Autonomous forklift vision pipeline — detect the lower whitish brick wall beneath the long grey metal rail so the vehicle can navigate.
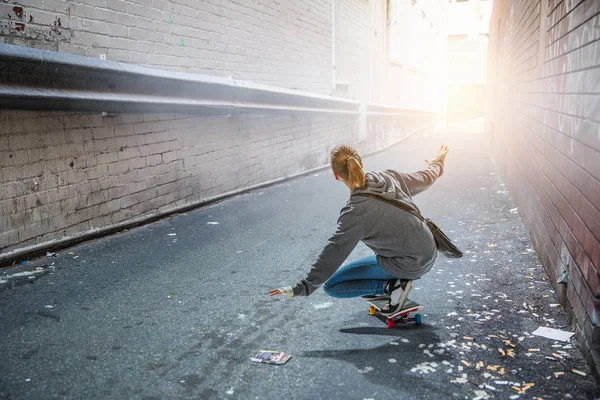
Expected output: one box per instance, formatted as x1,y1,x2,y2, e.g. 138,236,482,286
0,111,426,252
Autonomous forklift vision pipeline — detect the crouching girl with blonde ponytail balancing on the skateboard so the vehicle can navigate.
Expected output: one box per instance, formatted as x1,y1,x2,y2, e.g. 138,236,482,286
269,145,448,315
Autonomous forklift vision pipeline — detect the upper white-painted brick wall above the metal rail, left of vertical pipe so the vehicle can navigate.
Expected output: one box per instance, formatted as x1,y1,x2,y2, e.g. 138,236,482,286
0,0,332,93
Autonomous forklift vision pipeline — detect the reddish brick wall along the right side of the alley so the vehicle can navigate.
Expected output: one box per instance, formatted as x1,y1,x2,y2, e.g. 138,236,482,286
487,0,600,356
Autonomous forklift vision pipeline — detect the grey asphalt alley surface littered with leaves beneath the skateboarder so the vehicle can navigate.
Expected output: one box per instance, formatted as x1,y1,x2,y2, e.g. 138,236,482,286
0,120,596,400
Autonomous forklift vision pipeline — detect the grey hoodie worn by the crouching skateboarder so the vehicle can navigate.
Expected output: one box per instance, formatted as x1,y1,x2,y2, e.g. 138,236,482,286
293,162,444,296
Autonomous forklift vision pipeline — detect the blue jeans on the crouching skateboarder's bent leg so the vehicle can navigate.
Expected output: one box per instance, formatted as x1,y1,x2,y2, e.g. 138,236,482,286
323,255,398,298
